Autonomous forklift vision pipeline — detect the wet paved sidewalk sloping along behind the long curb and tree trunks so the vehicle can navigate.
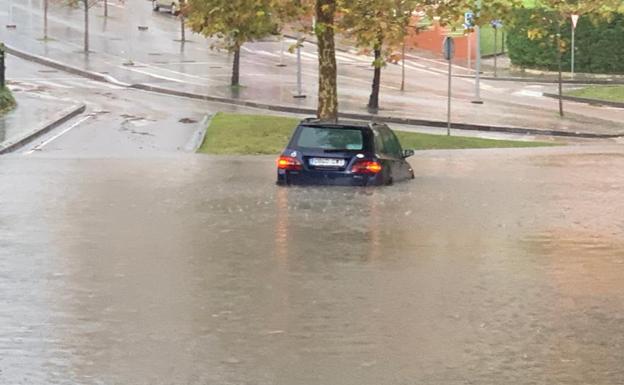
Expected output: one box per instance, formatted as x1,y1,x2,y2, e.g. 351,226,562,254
0,3,624,136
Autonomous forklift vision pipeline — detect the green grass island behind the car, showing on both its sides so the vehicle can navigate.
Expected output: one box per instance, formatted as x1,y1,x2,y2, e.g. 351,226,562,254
198,112,554,155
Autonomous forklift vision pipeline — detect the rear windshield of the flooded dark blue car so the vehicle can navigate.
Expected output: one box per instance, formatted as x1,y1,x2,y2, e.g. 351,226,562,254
297,126,364,151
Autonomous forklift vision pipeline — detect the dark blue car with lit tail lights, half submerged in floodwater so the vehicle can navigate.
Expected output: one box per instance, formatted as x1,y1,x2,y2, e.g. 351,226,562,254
277,119,414,186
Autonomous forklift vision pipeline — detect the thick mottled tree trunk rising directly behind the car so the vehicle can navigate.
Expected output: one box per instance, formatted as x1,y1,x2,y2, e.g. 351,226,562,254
315,0,338,121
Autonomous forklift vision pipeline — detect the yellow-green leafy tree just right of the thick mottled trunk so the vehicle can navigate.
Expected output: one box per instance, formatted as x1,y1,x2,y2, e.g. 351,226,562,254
341,0,419,111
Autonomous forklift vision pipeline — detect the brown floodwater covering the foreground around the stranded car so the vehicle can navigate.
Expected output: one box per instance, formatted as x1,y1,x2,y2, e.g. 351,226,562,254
0,147,624,385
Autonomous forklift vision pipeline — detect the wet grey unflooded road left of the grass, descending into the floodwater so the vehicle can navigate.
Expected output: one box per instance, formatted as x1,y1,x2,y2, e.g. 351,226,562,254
7,57,290,157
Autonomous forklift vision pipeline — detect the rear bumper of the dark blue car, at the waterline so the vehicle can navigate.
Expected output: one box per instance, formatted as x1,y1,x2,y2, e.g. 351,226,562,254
277,170,384,186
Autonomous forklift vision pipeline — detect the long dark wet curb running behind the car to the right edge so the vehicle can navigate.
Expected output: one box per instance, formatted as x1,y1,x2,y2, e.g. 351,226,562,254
130,84,624,139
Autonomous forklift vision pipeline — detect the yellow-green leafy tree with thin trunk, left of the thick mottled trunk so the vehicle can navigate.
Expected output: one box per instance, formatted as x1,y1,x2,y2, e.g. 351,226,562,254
187,0,277,86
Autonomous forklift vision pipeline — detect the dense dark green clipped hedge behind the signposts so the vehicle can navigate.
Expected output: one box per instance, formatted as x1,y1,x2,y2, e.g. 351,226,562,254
507,9,624,74
